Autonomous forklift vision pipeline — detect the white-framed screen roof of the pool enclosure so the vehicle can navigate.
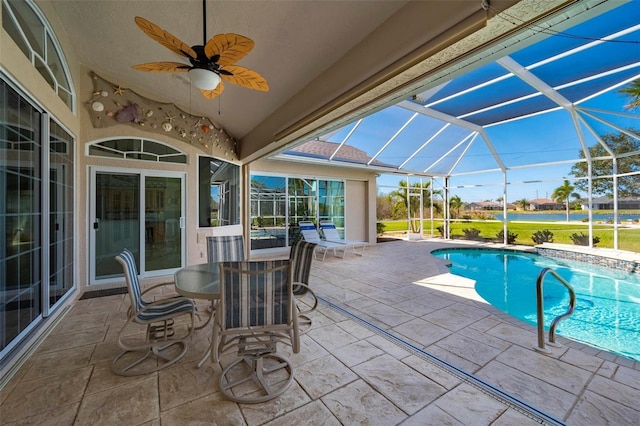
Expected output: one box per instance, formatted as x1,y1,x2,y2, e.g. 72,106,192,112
275,1,640,180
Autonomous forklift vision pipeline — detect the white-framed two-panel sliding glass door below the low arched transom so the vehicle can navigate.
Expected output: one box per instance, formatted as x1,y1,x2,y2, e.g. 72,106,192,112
90,169,184,284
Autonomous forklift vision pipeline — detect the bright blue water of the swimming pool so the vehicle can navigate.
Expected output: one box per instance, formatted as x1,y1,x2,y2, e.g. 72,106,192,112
432,249,640,361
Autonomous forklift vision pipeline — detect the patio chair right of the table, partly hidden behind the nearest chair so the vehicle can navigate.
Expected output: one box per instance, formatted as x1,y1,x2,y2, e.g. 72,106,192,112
289,240,318,334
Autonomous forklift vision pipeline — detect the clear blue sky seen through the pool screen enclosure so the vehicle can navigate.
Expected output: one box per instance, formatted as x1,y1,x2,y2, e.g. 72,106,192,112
327,1,640,202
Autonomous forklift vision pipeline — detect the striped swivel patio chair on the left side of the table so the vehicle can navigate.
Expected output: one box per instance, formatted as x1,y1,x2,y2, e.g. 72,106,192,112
111,249,196,376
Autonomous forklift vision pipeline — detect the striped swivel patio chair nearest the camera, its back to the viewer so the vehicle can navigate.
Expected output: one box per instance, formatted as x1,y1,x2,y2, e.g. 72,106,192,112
211,260,300,403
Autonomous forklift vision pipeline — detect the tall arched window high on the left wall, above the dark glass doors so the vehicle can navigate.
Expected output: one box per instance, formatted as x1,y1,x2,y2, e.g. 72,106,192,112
2,0,75,112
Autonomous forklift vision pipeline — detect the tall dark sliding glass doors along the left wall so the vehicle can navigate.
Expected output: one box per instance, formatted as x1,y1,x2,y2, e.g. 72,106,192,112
0,74,75,360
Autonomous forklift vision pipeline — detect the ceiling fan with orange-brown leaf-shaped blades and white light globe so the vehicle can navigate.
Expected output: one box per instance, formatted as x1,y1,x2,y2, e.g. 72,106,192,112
133,0,269,99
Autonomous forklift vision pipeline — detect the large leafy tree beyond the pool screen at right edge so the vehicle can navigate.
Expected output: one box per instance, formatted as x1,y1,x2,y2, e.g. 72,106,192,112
571,129,640,197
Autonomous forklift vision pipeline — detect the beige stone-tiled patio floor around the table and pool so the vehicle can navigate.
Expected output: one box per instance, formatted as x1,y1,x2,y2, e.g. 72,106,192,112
0,241,640,426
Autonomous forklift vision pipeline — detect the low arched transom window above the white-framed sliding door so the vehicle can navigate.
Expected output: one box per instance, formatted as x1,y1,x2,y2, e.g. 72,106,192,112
87,139,187,164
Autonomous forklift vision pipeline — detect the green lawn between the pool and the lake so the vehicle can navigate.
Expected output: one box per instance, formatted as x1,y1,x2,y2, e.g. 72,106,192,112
382,220,640,252
